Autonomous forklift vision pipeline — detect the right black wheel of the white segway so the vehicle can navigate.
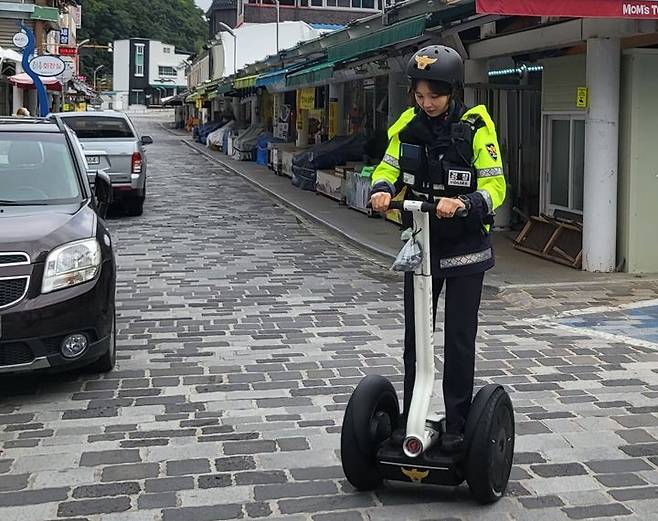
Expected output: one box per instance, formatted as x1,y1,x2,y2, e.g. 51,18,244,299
466,387,514,504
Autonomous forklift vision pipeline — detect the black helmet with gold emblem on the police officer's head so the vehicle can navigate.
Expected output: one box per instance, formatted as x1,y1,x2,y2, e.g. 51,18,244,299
407,45,464,89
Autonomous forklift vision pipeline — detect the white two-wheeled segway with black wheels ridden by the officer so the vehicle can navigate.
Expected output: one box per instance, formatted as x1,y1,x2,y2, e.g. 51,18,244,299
340,197,514,504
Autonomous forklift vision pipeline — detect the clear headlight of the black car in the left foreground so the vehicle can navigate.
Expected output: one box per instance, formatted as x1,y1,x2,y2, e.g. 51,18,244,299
41,239,101,293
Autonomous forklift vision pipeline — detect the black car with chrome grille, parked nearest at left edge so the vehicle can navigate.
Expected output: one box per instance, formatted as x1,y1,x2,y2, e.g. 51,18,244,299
0,118,116,374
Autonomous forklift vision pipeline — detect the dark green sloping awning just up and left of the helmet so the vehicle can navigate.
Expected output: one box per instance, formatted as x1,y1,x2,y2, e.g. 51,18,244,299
327,16,427,62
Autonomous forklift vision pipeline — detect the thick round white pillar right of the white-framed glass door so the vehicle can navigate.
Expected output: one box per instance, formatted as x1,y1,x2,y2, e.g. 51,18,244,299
583,38,621,272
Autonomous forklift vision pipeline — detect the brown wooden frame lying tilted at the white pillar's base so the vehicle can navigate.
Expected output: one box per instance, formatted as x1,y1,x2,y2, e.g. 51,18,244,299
514,214,583,269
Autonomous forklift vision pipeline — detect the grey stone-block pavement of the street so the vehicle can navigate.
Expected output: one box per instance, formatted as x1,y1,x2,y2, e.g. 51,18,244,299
0,114,658,521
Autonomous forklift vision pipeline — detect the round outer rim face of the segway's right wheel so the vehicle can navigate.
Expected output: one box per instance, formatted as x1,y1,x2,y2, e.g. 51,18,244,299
490,405,514,495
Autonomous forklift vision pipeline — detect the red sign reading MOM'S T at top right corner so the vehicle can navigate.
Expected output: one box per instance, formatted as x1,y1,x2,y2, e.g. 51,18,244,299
477,0,658,19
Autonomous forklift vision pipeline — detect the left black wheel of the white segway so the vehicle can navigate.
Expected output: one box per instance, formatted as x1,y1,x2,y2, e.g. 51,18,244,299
340,375,400,490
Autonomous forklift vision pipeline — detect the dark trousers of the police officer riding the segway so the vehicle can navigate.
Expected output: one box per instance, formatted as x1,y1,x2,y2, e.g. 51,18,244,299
404,273,484,433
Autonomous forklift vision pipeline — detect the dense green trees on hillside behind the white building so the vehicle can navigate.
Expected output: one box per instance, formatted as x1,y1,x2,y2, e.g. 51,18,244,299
78,0,208,83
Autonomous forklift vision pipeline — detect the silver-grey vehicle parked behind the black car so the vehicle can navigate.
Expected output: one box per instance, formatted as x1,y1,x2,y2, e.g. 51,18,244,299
53,111,153,216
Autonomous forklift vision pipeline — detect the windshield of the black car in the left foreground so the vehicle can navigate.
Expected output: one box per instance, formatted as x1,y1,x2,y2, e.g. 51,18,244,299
0,132,81,205
